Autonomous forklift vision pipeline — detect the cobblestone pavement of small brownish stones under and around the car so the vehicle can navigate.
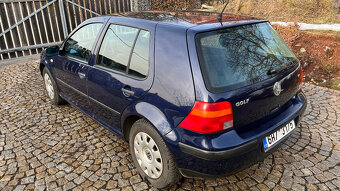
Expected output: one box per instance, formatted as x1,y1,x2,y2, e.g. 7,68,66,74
0,63,340,191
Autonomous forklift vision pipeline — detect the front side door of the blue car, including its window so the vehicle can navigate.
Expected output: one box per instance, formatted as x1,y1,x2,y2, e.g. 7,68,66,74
54,23,103,110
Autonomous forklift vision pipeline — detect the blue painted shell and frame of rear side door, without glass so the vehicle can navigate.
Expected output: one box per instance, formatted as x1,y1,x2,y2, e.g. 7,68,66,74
87,17,156,130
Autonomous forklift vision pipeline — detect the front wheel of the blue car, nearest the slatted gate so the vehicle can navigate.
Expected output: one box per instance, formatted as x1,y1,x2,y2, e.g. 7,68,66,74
42,67,65,105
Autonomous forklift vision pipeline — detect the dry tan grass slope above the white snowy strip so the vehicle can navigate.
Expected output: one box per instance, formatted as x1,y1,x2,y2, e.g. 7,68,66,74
215,0,340,24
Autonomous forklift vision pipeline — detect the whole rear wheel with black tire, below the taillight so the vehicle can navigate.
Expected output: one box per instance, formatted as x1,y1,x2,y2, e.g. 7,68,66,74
129,119,182,188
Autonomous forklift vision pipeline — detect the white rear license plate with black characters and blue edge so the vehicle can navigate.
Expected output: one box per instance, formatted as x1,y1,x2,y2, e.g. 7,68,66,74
263,120,295,151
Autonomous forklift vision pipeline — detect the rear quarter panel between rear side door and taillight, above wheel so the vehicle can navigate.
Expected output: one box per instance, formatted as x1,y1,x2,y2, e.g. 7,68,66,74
122,24,195,135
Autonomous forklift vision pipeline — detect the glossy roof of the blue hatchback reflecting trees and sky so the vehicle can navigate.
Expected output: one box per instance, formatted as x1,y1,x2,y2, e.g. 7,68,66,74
102,11,266,29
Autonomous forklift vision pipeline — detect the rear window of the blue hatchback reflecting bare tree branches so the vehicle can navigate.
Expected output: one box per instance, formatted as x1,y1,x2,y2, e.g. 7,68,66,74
196,23,298,92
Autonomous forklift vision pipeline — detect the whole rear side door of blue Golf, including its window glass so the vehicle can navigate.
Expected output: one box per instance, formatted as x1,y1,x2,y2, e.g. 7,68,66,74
88,23,153,128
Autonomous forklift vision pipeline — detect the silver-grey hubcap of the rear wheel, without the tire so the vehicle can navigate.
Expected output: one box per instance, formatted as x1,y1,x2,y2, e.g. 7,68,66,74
134,132,163,178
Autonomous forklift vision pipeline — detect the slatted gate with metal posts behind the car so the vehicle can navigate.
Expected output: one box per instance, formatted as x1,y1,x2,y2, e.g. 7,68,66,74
0,0,131,61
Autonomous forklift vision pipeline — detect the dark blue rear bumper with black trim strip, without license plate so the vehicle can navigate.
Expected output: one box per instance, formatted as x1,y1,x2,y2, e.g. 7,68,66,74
165,93,307,177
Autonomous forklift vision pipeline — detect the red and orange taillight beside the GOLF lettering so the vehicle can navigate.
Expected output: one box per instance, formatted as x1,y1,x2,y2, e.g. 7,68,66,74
179,101,233,133
